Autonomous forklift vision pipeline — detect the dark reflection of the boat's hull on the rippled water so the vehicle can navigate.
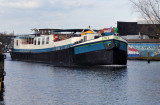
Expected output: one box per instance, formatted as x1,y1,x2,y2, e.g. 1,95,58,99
59,66,127,80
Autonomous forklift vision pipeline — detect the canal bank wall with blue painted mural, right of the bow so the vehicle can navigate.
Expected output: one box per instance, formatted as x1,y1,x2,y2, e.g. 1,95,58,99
127,39,160,61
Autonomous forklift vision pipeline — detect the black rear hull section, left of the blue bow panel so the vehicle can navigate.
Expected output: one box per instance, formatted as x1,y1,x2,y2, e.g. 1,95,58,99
10,48,74,66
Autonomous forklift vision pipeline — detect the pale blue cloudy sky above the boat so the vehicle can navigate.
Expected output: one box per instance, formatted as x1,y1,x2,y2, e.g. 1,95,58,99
0,0,137,34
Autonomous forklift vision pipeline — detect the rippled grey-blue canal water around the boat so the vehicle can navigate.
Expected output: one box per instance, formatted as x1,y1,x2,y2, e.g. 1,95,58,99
0,54,160,105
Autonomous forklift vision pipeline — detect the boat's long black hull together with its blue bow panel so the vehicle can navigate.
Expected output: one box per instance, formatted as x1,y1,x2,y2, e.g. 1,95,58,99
11,40,127,66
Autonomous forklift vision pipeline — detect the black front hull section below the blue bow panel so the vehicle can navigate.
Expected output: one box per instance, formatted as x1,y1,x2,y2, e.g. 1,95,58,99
75,48,127,65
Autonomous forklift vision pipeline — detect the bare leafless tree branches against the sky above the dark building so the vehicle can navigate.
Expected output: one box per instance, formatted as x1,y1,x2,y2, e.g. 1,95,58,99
130,0,160,24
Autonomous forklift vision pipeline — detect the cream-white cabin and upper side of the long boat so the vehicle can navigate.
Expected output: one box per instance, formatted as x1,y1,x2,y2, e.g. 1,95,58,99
14,33,125,49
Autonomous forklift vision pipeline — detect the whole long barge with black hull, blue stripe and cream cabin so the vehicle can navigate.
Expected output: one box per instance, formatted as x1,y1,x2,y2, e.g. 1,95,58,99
10,29,127,66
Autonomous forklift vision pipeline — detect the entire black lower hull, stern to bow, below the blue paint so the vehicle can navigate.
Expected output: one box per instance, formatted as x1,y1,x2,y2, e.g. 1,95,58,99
11,47,127,66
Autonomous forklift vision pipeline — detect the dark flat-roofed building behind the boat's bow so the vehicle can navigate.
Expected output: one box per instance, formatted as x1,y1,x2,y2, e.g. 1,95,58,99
117,21,160,39
